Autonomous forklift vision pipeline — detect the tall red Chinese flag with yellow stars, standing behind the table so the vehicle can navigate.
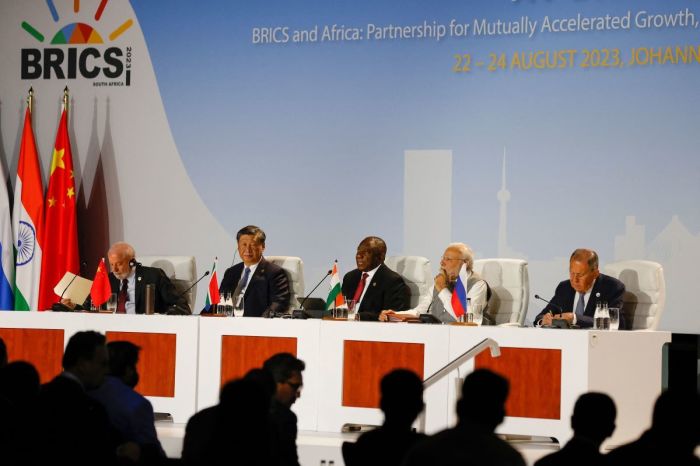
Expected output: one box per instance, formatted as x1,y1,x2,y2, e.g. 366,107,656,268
39,106,80,310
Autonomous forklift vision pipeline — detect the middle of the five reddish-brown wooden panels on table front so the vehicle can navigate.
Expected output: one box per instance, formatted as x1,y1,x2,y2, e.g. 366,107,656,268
220,335,297,386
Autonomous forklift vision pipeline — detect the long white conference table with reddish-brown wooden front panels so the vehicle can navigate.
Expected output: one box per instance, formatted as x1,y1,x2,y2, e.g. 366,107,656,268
0,312,671,445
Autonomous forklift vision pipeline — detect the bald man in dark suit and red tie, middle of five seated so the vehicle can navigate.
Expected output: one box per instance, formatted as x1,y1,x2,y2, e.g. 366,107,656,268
342,236,411,320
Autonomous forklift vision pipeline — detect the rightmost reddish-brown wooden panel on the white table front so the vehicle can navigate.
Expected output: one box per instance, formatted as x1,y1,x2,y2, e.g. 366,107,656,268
474,347,561,419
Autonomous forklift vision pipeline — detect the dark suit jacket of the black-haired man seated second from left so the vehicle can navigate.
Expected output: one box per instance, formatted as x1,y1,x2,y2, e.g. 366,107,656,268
219,257,291,317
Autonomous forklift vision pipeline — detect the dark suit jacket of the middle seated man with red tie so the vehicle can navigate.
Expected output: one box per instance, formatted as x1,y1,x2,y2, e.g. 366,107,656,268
342,264,411,320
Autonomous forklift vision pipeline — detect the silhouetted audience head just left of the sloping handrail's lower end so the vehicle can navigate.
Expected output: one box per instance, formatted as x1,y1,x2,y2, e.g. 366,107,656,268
379,369,424,426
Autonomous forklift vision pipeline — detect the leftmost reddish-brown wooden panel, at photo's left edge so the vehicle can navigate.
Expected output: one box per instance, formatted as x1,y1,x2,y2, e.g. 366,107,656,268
0,328,65,383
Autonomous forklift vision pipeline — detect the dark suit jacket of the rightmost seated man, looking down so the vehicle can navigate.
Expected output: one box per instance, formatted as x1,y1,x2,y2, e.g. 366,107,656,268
535,273,627,329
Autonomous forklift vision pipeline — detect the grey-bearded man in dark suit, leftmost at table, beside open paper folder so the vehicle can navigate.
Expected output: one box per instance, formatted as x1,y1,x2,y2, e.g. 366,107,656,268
107,242,191,314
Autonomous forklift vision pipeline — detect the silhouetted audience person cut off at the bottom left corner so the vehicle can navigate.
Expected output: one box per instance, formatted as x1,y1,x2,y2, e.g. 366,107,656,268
0,361,41,465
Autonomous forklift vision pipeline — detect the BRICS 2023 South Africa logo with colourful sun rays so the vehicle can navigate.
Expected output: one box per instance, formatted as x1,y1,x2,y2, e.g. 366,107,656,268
21,0,134,86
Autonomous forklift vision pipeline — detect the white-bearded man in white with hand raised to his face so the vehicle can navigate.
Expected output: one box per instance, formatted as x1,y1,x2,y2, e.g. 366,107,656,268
379,243,491,325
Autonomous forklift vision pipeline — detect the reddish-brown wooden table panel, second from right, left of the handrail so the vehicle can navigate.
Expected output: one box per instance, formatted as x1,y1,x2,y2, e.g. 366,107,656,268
343,340,425,408
